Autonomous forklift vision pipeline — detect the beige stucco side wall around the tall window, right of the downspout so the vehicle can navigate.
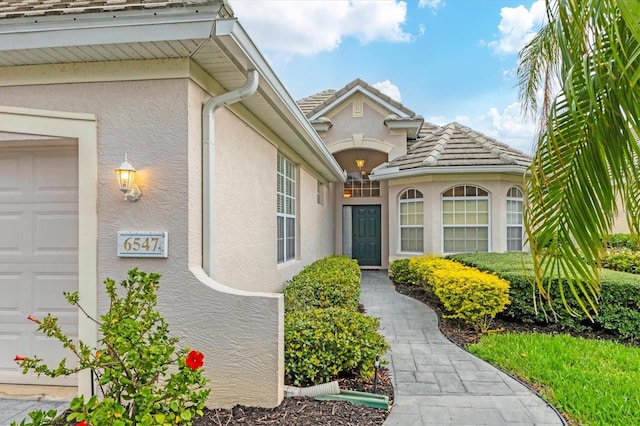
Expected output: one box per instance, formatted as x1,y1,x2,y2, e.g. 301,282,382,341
214,109,340,292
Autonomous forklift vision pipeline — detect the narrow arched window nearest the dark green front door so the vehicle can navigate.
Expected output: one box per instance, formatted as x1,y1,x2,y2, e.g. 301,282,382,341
399,189,424,253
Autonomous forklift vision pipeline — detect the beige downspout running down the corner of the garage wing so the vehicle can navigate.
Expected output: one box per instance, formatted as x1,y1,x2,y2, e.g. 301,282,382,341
202,70,259,279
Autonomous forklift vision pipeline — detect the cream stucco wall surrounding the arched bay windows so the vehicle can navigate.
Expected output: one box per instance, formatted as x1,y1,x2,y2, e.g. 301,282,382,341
389,173,523,262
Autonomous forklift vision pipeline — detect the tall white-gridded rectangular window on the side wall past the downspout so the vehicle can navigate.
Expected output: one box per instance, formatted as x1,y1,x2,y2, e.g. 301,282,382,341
277,153,296,263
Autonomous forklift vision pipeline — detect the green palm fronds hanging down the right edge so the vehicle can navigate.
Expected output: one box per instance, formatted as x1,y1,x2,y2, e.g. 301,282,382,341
518,0,640,314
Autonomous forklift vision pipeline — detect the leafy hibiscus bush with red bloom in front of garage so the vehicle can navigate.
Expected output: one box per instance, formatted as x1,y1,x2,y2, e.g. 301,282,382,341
15,269,209,426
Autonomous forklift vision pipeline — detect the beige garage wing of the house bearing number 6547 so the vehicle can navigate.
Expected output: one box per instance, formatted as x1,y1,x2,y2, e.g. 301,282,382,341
0,0,346,406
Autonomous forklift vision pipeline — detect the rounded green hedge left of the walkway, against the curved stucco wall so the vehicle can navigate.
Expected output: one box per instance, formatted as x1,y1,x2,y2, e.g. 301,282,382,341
284,255,389,385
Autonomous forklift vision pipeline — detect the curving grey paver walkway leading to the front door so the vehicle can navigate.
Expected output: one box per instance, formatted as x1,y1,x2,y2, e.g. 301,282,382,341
360,271,565,426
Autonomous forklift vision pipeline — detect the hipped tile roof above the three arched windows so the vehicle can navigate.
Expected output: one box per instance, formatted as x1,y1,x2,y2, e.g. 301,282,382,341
387,122,531,171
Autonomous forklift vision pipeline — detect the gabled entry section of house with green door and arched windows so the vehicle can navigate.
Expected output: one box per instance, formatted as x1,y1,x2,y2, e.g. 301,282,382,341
298,79,531,269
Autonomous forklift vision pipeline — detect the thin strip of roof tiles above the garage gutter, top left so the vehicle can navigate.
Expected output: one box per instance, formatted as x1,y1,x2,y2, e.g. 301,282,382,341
0,0,233,19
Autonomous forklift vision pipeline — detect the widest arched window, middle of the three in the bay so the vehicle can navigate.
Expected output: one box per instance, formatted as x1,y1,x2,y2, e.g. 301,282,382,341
442,185,489,253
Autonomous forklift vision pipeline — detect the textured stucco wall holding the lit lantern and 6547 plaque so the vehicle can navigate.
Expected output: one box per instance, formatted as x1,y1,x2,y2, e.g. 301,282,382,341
0,79,283,406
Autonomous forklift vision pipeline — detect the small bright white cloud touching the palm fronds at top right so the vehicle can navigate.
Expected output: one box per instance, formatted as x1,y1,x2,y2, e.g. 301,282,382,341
486,0,546,54
